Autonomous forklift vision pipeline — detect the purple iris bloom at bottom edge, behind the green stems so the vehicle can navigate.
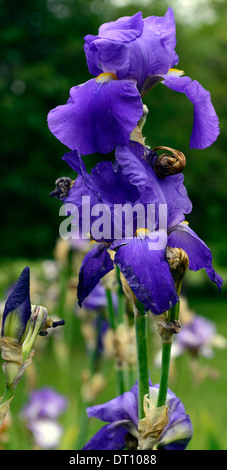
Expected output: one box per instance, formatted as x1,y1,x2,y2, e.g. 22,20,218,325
84,383,193,450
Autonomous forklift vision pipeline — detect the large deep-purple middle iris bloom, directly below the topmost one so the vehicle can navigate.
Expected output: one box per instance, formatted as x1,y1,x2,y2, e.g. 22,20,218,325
63,143,222,314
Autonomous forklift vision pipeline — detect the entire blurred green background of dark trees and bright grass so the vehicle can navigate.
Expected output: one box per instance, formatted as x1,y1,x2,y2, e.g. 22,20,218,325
0,0,227,449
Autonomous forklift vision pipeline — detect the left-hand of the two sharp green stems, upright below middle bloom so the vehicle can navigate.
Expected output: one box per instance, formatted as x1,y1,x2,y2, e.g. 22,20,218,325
135,312,149,421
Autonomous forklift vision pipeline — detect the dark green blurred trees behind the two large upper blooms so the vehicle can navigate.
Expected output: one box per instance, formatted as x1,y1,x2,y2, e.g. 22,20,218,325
0,0,227,266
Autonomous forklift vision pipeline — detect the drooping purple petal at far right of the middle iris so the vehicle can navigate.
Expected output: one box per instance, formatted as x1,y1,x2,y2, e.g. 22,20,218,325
167,223,223,289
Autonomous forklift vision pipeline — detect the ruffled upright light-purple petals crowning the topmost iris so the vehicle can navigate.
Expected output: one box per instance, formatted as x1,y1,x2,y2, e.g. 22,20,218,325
84,8,178,90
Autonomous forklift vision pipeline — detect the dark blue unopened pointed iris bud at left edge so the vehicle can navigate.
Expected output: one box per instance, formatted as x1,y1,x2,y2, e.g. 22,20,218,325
1,266,31,342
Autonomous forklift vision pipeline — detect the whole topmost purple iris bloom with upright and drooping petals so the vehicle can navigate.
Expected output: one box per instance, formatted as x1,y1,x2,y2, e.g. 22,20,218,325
48,8,219,155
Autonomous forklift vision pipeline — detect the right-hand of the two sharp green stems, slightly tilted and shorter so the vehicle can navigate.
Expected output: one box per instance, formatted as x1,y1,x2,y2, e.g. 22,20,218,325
157,341,172,407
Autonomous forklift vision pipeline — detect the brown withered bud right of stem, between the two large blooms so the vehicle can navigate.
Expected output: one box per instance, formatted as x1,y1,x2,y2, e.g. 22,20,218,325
153,146,186,178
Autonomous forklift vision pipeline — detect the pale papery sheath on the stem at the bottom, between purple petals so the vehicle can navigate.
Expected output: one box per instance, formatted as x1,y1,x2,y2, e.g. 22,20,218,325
138,395,169,450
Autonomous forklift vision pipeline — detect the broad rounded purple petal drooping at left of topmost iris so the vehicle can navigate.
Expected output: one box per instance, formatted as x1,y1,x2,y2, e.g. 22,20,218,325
48,73,143,155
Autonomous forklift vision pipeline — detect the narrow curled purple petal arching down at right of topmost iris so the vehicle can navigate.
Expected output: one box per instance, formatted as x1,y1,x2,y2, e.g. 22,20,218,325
163,71,220,149
